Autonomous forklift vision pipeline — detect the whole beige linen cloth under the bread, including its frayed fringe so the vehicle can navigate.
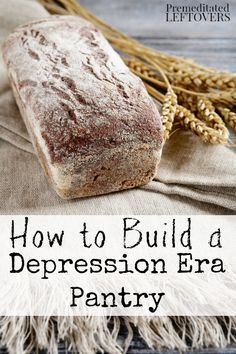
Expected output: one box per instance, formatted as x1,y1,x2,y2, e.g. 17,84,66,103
0,0,236,354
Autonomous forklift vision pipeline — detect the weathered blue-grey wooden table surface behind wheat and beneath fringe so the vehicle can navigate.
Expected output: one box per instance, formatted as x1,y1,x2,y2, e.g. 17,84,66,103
0,0,236,354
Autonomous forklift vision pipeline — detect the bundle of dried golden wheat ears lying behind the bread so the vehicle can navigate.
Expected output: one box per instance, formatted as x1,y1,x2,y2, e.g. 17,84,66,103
38,0,236,145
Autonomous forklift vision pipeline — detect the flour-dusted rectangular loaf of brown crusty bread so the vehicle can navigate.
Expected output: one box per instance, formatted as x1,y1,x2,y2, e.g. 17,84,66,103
3,16,163,198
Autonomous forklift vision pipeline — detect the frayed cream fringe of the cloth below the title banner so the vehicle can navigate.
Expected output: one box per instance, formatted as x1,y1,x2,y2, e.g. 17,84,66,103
0,316,236,354
